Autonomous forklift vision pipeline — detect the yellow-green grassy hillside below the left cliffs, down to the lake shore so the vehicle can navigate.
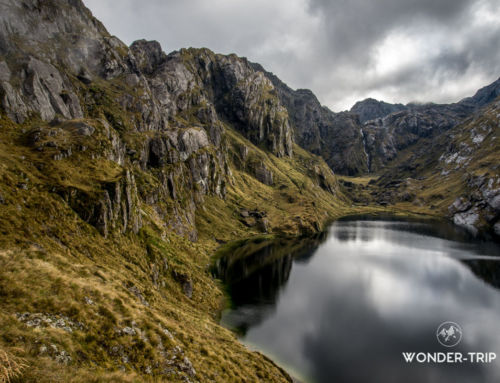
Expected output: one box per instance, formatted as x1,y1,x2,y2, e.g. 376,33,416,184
0,106,368,382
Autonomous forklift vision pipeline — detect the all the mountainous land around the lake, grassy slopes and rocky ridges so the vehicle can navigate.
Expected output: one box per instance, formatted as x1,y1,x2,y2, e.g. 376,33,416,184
0,0,500,382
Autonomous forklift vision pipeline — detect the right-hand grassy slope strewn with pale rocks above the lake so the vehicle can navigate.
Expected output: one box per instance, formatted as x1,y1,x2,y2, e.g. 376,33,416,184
376,98,500,235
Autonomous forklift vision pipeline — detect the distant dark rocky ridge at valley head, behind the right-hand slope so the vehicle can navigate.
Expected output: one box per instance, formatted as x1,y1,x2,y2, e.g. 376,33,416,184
252,64,500,176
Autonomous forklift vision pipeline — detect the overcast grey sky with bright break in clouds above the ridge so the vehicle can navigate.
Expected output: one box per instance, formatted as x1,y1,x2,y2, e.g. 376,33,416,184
84,0,500,111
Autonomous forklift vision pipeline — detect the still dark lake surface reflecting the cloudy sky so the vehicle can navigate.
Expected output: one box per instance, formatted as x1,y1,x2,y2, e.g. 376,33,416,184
216,219,500,383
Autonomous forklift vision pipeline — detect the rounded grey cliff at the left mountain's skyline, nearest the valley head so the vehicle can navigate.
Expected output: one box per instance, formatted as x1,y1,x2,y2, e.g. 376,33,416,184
131,47,293,156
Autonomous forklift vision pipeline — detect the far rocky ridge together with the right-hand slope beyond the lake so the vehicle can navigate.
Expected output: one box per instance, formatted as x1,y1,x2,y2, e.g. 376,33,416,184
254,51,500,235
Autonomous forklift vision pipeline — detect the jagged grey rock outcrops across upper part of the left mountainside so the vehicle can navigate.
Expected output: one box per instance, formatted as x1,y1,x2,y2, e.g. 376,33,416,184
0,0,302,239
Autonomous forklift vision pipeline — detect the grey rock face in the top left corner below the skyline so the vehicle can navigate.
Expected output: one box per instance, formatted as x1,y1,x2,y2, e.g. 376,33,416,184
0,0,119,122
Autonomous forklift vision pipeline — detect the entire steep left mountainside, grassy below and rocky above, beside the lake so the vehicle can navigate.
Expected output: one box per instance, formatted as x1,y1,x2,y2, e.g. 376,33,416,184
0,0,349,382
